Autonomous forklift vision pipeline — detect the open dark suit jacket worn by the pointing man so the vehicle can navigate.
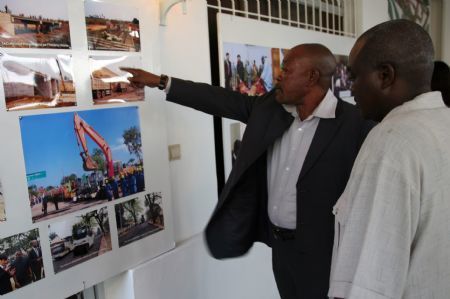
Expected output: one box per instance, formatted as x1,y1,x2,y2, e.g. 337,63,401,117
167,78,374,299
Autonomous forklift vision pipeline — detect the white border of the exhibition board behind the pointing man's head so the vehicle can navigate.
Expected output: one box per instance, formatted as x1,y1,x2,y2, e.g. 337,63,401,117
217,13,355,178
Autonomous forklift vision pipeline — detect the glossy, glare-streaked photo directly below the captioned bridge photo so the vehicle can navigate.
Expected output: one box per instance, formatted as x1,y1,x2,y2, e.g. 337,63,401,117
0,53,77,111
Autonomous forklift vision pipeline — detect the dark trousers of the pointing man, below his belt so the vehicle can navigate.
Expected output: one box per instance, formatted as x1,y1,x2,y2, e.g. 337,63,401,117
272,230,328,299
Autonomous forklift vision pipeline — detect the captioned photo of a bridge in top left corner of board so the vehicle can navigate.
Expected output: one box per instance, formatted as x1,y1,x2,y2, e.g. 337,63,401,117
0,0,71,49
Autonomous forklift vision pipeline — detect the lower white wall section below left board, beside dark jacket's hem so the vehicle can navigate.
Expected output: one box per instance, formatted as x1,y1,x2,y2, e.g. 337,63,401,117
132,235,279,299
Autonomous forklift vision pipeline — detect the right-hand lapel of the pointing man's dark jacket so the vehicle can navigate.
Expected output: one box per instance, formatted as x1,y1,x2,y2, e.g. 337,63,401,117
299,100,342,181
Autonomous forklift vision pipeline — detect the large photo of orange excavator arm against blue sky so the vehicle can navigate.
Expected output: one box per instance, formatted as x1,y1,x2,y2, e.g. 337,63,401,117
20,107,145,222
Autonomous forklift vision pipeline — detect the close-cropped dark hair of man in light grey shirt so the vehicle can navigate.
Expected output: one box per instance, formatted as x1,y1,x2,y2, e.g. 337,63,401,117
357,20,434,89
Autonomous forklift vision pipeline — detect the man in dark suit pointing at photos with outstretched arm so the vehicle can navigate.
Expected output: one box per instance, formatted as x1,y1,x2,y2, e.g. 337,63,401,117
124,44,373,299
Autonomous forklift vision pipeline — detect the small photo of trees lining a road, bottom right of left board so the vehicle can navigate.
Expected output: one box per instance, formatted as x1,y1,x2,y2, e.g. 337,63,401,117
115,192,164,247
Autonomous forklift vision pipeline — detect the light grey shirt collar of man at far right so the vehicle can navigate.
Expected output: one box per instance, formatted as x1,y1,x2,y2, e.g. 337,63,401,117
385,91,447,119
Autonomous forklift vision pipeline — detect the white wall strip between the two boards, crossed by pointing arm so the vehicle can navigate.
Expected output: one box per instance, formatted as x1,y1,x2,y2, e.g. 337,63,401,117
160,0,218,245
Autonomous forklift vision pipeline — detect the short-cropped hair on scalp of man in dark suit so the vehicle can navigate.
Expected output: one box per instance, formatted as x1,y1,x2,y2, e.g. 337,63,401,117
289,44,336,89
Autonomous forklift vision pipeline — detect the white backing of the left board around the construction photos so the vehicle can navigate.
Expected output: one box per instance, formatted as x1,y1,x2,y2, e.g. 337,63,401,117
0,0,175,299
